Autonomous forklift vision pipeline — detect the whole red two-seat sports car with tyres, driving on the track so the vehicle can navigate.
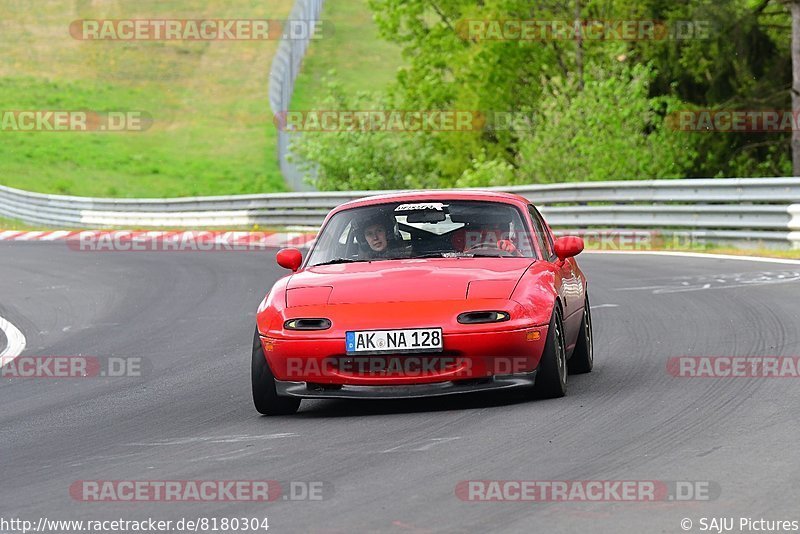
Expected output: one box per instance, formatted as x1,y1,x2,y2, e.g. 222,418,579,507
252,191,593,415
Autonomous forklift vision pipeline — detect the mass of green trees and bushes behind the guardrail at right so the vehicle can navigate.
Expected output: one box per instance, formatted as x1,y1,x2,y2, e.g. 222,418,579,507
295,0,800,189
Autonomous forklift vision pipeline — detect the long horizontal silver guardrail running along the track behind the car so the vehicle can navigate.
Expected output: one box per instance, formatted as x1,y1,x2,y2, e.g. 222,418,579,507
0,178,800,248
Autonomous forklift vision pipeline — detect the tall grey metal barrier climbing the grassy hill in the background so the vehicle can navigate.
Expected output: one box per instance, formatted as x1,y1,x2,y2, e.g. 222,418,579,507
269,0,323,191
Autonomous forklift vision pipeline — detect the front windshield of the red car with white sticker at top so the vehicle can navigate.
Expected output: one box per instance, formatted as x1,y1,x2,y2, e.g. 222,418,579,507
307,200,535,267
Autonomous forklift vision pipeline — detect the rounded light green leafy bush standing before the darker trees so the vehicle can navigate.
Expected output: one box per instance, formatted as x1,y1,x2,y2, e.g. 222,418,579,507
516,61,697,183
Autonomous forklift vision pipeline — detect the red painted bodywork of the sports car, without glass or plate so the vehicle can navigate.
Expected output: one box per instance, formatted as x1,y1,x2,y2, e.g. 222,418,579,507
257,191,586,397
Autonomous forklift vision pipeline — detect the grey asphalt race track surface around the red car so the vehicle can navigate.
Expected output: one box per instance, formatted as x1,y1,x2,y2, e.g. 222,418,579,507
0,242,800,533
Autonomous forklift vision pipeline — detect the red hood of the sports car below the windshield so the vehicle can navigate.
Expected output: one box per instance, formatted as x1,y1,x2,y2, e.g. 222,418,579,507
286,258,533,307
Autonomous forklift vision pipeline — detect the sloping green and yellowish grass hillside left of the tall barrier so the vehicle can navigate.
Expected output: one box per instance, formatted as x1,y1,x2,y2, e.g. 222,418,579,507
0,0,292,197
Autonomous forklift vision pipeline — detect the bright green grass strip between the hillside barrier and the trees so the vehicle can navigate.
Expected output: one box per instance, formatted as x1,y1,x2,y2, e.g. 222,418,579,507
291,0,402,111
